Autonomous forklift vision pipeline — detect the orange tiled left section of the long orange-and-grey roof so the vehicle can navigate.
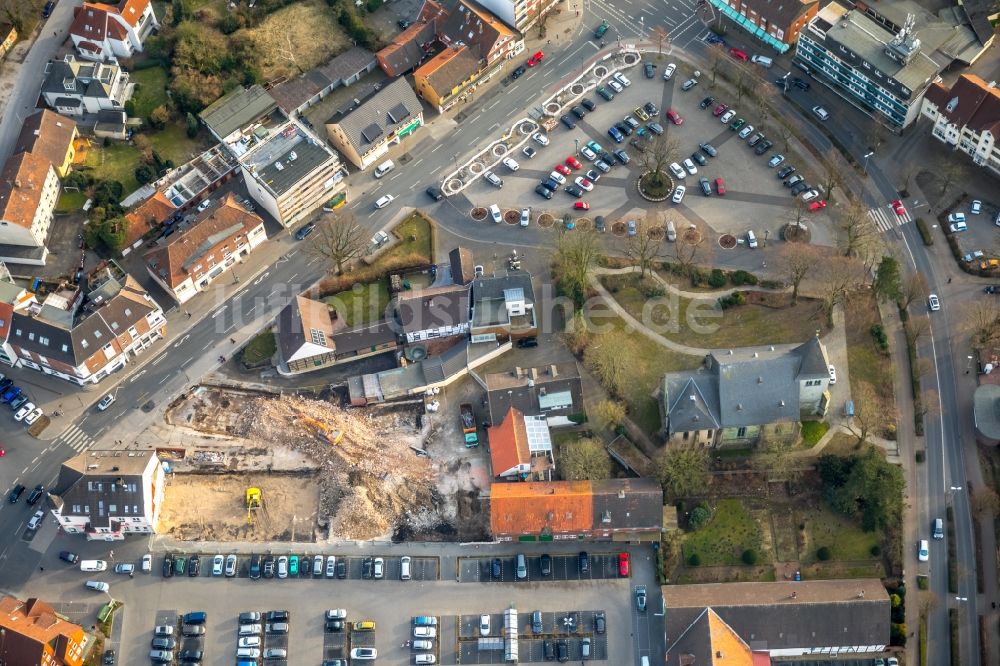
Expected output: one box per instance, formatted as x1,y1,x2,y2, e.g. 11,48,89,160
490,481,594,536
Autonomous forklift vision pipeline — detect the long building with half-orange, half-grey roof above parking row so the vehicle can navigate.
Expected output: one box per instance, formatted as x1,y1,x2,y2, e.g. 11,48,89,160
490,479,663,541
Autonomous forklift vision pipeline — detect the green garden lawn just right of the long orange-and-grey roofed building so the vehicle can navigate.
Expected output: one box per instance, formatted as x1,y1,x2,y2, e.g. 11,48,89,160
683,499,766,566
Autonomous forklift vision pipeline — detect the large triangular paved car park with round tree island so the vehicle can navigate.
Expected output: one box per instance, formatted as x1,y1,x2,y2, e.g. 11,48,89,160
466,55,834,250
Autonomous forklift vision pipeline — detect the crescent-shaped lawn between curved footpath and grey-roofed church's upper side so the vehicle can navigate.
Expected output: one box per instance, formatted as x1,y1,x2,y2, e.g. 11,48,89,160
601,275,824,348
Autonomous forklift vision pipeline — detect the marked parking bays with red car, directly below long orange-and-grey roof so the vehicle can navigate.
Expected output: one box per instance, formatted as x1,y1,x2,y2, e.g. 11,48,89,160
458,553,619,583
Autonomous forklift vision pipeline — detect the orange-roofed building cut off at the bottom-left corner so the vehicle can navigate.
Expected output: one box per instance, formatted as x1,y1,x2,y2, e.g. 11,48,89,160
0,596,93,666
